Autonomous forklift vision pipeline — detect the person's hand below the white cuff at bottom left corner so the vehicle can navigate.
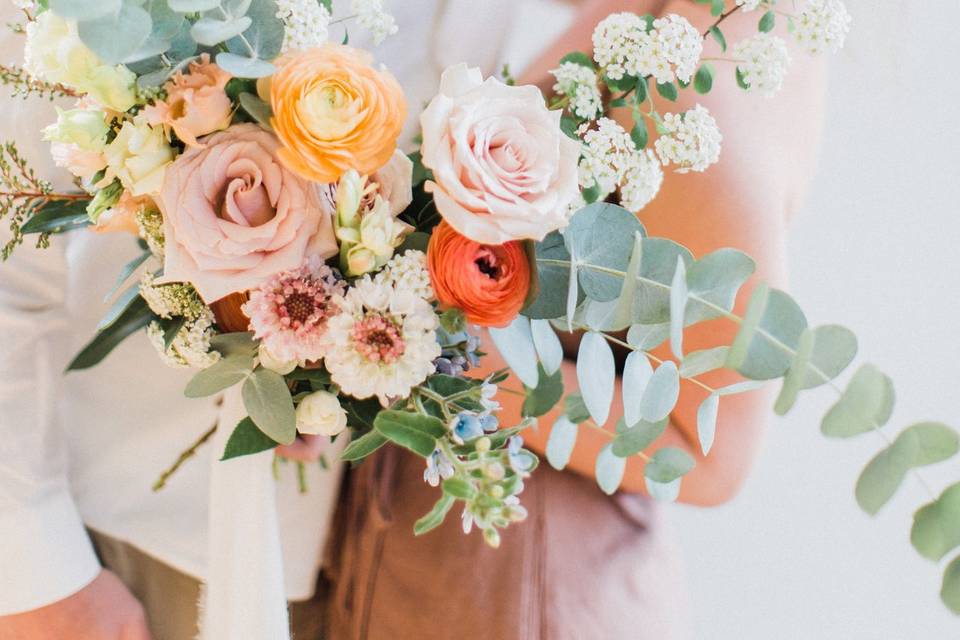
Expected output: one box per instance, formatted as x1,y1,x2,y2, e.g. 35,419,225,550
0,569,150,640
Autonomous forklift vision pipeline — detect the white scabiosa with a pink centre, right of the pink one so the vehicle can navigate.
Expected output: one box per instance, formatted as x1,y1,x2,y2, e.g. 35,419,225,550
324,276,440,406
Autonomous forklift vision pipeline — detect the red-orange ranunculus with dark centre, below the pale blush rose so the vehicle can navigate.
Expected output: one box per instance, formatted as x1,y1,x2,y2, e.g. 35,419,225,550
427,222,530,327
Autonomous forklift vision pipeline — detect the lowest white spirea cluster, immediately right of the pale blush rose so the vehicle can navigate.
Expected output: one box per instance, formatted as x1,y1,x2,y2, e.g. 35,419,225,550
580,118,663,212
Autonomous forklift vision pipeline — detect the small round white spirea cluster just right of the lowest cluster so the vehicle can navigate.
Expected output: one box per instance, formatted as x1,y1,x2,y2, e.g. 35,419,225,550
656,104,723,173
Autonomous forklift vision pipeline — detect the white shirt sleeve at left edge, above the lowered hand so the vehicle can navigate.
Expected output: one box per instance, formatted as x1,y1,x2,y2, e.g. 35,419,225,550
0,2,100,615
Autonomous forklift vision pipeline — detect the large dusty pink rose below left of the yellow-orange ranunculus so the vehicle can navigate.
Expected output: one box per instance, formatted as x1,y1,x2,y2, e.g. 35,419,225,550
157,124,337,303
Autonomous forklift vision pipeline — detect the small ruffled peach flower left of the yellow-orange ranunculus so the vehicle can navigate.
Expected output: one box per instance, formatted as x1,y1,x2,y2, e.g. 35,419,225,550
144,53,233,147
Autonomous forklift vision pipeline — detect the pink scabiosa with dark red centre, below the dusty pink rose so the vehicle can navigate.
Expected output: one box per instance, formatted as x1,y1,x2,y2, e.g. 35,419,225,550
243,257,346,362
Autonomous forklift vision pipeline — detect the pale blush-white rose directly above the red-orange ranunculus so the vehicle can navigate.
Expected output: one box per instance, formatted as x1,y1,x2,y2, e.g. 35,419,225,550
420,64,580,244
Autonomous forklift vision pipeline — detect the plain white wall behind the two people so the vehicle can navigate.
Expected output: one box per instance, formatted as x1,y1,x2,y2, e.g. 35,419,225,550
508,0,960,640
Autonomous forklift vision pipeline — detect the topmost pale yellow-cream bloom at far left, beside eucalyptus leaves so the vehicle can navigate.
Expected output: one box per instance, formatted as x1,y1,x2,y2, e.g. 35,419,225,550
24,11,137,111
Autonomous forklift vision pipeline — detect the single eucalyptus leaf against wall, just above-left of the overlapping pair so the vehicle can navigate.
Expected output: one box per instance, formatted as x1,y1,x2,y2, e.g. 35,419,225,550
820,364,896,438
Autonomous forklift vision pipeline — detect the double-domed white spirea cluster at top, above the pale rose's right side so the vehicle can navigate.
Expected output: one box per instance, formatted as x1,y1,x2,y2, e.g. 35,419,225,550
593,13,703,84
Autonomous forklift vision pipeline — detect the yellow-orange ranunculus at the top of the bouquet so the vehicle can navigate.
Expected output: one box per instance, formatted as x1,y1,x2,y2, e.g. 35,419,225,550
270,45,407,183
